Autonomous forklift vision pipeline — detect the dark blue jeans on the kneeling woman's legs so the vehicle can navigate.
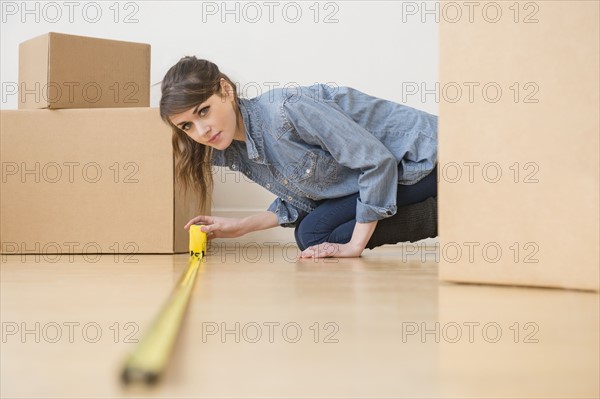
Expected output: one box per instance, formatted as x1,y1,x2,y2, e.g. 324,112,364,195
294,166,437,250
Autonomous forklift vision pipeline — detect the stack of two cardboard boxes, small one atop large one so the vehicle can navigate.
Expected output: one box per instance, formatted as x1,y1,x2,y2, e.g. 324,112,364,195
0,33,209,254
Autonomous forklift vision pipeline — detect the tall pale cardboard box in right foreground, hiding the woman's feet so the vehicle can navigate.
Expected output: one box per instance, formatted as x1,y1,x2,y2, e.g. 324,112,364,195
439,1,600,291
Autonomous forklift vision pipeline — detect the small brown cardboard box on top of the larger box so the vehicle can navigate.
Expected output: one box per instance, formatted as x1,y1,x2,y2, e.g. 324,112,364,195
18,32,150,109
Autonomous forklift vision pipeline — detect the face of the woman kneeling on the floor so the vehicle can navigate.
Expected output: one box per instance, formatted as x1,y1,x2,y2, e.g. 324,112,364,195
169,79,246,150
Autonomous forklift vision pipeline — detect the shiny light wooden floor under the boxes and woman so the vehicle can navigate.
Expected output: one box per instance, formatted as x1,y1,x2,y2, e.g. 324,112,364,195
0,245,600,398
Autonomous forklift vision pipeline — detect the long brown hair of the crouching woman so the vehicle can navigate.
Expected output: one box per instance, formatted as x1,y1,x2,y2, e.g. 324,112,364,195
160,56,241,209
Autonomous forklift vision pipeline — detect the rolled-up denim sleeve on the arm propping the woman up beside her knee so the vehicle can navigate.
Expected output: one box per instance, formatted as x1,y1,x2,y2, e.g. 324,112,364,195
283,95,398,223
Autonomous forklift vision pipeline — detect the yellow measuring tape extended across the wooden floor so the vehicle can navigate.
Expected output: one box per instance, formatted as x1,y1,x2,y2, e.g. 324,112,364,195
121,224,206,385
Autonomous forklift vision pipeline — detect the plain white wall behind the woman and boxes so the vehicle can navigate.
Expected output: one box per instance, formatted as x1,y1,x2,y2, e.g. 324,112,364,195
0,1,438,247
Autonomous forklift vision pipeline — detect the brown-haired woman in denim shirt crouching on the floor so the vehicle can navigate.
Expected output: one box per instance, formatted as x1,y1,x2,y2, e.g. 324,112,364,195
160,57,437,257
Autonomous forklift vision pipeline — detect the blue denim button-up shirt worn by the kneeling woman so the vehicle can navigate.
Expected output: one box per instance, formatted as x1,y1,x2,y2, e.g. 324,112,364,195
212,84,437,227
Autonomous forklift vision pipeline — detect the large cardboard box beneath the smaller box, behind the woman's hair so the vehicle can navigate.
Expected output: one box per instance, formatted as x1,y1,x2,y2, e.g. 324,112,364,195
0,108,210,254
